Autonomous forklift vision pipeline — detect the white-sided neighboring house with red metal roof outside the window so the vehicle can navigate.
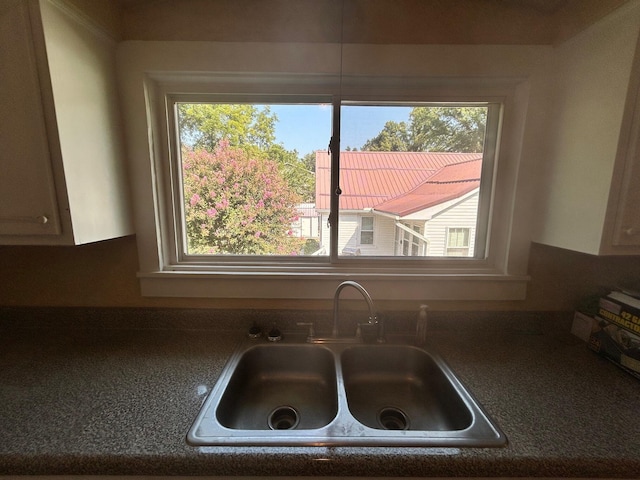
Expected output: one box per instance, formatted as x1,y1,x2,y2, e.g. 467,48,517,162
316,152,482,256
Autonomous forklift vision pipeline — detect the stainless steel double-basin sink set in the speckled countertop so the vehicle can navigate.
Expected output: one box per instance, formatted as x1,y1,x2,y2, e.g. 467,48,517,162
187,341,507,447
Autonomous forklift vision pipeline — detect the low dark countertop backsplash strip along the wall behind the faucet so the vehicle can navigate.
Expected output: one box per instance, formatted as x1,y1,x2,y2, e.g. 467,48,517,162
0,307,573,335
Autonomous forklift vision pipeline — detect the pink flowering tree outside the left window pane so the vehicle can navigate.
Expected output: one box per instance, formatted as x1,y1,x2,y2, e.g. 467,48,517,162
182,141,303,255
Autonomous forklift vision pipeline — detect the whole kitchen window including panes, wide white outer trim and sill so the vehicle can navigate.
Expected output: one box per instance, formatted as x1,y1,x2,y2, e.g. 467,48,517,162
121,45,527,301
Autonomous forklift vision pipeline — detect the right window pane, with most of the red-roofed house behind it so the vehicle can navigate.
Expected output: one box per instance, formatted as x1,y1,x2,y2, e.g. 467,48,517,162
338,103,488,256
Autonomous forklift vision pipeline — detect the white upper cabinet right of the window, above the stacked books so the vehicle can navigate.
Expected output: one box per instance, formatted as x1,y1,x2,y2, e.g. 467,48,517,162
533,2,640,255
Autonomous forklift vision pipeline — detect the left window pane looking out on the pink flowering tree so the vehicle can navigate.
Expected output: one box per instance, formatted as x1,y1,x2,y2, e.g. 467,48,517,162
176,103,331,256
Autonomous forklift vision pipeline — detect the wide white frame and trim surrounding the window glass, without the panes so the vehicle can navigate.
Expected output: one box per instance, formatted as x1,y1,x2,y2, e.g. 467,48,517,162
119,46,529,301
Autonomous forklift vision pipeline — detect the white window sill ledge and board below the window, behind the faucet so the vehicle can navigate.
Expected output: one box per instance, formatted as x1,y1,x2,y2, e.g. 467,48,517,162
139,270,529,301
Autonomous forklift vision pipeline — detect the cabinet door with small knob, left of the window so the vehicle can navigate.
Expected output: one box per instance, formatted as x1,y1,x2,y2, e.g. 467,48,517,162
0,0,60,235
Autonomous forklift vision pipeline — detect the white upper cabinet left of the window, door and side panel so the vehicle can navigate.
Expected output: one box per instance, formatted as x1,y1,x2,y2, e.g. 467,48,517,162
0,0,133,245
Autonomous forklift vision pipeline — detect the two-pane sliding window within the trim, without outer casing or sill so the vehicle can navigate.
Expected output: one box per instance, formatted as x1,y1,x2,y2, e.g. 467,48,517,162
168,95,501,261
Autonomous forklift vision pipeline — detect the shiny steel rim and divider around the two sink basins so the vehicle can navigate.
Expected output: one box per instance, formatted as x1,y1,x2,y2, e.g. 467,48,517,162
186,337,507,447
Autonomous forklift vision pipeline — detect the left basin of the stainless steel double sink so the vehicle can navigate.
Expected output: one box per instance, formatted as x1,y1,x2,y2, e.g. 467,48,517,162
216,345,338,430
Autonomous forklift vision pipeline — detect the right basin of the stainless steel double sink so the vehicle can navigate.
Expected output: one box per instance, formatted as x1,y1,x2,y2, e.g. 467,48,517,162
341,345,473,431
